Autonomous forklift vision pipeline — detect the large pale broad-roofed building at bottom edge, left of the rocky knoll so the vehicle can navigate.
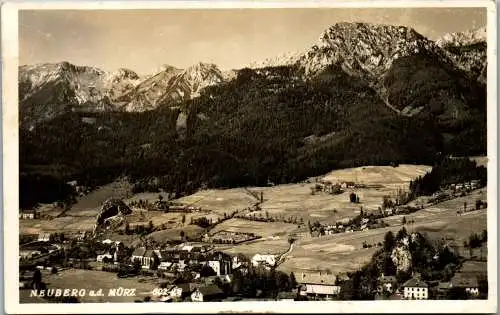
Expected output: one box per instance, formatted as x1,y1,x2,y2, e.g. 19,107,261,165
297,272,340,300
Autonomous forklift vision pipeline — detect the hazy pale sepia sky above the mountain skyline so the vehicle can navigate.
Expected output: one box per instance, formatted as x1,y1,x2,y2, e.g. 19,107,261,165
19,8,486,74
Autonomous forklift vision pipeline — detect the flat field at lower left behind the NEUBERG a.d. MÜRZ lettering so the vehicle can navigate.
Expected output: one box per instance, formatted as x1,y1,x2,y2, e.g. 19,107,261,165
20,269,158,303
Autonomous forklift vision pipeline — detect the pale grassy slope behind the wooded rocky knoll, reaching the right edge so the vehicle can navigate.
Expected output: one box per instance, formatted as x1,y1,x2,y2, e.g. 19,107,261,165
280,189,487,273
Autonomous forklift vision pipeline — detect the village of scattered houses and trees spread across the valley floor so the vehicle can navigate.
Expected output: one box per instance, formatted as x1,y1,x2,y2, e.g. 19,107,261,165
19,163,487,302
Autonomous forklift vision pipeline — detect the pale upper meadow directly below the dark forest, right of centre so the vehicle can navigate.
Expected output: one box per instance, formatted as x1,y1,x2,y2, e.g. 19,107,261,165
244,165,431,223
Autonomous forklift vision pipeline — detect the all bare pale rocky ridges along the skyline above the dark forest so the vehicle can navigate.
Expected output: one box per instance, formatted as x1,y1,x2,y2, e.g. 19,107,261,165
19,23,486,126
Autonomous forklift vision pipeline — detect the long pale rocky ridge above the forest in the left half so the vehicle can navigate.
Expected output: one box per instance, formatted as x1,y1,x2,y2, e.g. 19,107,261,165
19,62,236,127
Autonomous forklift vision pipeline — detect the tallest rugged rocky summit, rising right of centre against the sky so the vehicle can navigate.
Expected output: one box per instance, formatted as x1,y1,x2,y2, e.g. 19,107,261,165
299,22,439,78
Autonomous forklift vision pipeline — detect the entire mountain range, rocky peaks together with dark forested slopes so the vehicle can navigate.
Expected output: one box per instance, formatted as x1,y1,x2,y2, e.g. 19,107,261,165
19,23,487,210
